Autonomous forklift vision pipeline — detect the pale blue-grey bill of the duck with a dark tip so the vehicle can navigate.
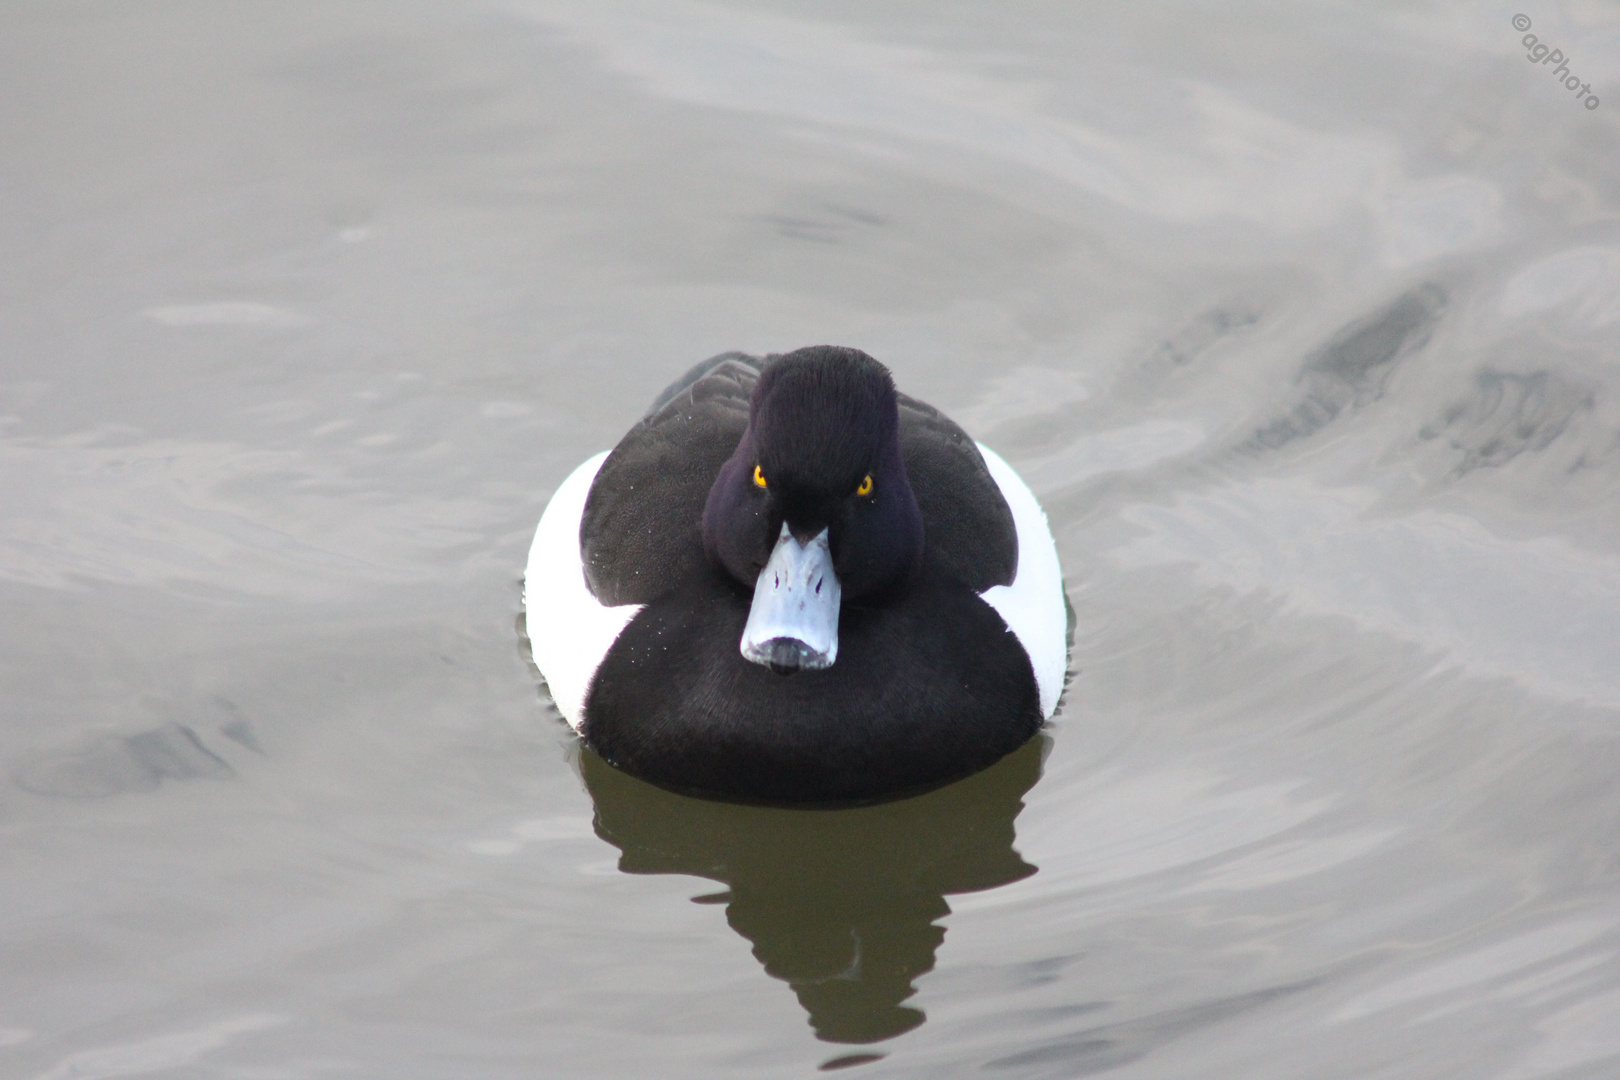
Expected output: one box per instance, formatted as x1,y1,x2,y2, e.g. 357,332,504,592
742,523,841,675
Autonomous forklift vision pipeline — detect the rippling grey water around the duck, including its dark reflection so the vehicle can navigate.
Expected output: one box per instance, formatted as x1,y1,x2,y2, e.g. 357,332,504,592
0,0,1620,1080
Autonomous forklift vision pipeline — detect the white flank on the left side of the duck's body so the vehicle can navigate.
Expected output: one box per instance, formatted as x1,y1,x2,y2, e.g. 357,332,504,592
523,450,642,730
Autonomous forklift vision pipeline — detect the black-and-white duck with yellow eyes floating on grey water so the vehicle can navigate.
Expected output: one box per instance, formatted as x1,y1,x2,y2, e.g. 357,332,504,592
523,345,1069,806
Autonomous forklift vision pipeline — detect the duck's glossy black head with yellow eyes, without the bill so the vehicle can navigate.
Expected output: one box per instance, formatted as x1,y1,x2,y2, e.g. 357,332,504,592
703,345,923,670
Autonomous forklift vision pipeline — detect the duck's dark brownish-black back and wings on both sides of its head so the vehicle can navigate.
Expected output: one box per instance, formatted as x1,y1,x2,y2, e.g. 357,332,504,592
580,353,1017,606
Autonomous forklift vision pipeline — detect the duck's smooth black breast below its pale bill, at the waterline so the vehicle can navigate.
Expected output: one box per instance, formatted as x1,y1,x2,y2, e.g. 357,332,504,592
585,570,1042,803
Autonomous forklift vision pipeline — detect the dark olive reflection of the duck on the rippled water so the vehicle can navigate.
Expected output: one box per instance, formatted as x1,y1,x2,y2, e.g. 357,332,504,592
582,735,1050,1043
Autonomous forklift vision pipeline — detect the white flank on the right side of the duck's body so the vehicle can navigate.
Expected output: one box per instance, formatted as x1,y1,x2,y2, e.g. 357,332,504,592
977,442,1069,717
